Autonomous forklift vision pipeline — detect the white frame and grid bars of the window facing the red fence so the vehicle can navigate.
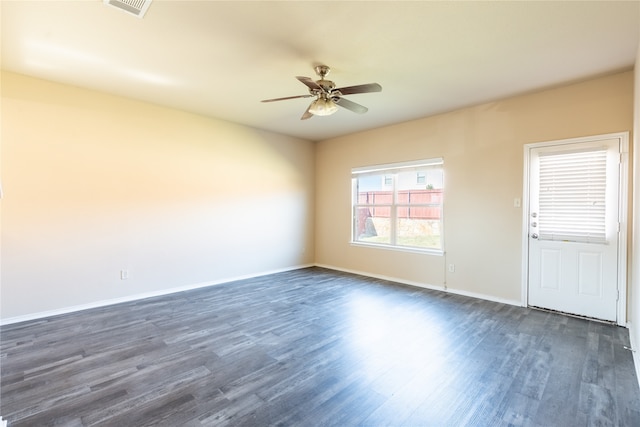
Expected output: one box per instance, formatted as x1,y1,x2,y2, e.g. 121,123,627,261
350,157,445,255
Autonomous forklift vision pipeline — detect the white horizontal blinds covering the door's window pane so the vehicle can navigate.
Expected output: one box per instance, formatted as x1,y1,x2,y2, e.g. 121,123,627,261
538,147,607,243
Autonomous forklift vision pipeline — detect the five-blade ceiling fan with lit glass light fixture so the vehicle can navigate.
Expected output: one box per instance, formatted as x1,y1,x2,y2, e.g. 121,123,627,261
262,65,382,120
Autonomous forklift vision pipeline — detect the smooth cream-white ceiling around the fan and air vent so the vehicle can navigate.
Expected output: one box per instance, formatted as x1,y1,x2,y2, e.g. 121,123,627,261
0,0,640,141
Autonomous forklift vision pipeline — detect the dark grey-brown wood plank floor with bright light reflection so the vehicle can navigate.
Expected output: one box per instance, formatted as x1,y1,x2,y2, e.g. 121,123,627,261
0,268,640,427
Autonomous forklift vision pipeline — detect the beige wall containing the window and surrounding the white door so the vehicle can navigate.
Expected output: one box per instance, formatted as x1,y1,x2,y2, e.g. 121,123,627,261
316,72,633,303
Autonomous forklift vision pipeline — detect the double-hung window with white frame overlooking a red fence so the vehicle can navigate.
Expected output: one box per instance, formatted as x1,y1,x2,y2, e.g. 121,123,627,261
351,159,443,252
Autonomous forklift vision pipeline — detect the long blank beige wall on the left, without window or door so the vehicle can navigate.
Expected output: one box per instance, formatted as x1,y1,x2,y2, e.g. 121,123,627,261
0,73,315,319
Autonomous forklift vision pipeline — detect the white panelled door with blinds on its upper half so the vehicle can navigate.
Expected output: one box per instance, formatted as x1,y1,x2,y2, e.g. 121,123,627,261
528,138,621,321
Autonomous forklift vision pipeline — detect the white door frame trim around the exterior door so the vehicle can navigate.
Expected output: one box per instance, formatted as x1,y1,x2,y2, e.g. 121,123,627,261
521,132,629,327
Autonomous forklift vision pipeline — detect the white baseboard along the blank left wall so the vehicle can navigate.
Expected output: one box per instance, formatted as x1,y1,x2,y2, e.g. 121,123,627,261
0,264,314,326
